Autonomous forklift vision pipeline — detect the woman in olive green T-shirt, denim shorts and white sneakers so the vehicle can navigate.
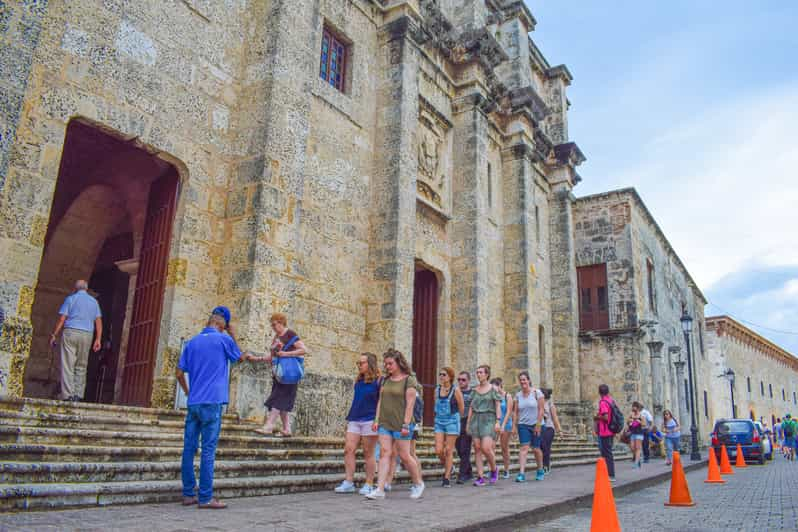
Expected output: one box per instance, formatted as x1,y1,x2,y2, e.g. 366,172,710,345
366,349,424,499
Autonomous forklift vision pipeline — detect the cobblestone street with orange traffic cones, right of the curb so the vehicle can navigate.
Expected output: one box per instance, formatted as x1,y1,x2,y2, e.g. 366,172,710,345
526,457,798,532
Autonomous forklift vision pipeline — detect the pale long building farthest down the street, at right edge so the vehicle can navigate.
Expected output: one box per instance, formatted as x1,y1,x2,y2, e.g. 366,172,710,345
704,316,798,427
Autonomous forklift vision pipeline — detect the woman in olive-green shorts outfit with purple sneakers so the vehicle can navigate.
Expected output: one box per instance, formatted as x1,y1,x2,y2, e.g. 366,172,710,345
466,365,502,486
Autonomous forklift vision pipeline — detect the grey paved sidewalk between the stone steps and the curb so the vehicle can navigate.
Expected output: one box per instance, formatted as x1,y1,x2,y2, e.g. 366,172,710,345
0,460,701,531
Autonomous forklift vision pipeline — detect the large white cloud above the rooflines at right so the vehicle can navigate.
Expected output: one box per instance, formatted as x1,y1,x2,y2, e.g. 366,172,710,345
612,84,798,288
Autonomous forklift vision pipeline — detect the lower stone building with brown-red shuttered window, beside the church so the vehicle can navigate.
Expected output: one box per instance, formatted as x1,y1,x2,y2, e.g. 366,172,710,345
574,189,711,432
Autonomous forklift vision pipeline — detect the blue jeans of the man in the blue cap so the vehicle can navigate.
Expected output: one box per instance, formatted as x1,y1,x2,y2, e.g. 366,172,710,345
180,403,223,504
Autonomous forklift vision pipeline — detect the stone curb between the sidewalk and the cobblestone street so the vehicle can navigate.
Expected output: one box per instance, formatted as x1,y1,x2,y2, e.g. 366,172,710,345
449,460,708,532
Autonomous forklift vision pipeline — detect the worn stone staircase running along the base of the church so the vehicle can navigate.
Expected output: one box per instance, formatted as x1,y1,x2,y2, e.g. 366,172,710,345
0,398,628,511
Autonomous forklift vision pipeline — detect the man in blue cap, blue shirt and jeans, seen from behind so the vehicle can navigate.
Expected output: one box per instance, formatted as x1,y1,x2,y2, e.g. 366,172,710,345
176,313,249,509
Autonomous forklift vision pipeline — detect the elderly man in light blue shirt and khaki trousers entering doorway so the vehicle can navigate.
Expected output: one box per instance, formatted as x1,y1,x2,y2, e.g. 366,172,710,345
50,279,103,401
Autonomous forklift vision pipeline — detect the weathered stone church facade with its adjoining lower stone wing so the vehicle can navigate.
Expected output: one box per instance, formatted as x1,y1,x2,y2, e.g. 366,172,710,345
0,0,792,434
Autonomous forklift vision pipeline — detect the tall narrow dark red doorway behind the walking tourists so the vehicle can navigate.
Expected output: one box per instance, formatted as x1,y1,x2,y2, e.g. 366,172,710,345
413,269,440,425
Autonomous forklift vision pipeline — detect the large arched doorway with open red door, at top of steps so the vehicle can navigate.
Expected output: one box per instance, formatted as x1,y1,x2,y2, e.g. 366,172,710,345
24,119,179,406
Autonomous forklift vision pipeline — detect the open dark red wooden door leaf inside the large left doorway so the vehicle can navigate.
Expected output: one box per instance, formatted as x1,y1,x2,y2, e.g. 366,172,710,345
121,171,178,406
